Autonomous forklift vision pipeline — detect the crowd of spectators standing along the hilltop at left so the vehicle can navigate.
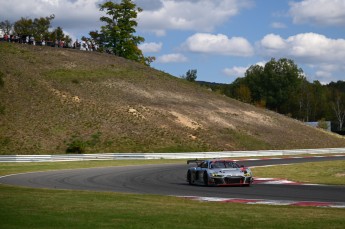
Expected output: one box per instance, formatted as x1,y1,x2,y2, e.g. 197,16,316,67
0,34,98,51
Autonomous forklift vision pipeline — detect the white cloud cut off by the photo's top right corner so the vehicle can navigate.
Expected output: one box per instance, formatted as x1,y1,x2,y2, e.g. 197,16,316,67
289,0,345,26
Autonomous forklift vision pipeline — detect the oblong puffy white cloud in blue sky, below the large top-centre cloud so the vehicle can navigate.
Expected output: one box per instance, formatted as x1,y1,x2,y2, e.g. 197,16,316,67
183,33,254,56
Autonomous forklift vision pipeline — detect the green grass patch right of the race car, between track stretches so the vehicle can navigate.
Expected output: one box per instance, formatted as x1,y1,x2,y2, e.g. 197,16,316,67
252,160,345,185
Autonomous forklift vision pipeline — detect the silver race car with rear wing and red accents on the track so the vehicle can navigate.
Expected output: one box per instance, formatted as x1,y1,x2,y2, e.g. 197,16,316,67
187,159,253,186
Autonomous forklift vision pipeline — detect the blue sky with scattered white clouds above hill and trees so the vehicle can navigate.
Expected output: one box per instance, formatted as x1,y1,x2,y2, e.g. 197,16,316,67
0,0,345,84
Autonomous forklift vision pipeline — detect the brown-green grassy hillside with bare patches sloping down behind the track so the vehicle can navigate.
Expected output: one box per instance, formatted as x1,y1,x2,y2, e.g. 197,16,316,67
0,42,345,154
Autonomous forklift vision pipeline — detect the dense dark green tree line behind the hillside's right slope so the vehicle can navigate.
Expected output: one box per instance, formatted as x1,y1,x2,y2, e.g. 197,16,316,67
196,58,345,131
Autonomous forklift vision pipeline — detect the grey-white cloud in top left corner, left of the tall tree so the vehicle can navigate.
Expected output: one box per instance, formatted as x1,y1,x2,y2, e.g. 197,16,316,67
0,0,103,37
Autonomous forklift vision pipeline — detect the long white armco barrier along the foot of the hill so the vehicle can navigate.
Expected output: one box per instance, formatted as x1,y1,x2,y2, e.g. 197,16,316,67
0,148,345,162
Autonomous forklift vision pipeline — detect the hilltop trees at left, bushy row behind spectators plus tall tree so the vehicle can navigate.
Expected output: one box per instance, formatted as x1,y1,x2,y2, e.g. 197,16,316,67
0,0,155,65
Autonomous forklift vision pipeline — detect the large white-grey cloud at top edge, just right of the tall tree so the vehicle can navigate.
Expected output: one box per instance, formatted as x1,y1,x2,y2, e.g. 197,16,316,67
138,0,252,35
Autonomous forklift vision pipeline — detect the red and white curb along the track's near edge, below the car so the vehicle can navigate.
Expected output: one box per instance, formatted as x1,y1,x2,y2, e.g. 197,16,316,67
178,196,345,208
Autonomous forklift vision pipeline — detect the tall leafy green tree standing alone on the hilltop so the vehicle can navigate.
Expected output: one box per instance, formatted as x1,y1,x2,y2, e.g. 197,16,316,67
97,0,148,63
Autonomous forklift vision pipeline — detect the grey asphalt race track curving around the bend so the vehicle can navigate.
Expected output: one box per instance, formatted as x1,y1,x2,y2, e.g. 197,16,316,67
0,156,345,203
